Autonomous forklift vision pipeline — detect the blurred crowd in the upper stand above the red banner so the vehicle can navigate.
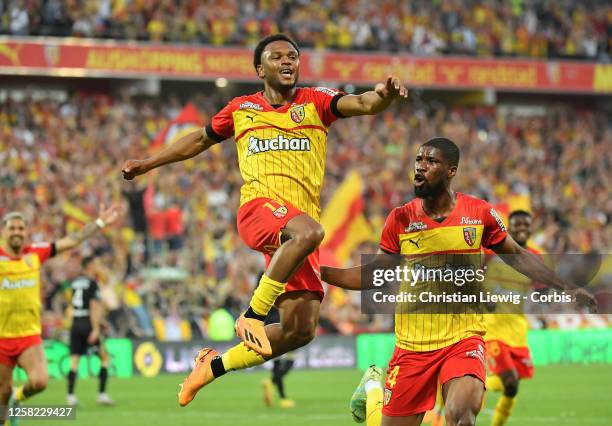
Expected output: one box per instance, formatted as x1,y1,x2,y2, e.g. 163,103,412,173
0,0,612,61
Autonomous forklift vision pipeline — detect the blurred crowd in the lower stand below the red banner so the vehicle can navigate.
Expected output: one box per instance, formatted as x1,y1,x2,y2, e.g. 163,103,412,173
0,88,612,340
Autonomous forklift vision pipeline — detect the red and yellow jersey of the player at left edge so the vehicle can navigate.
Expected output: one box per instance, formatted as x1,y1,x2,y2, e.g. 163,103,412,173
0,243,54,339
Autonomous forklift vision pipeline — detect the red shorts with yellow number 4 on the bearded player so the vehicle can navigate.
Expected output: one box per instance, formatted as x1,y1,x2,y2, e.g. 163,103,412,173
383,336,485,416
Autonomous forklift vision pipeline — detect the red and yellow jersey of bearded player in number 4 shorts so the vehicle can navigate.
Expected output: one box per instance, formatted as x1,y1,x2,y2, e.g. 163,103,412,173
380,192,507,352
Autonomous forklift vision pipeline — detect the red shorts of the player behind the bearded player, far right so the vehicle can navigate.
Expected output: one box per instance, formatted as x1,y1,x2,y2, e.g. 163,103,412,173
487,340,533,379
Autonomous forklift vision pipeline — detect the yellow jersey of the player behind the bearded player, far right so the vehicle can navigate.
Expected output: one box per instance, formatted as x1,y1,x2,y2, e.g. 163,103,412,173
485,247,540,348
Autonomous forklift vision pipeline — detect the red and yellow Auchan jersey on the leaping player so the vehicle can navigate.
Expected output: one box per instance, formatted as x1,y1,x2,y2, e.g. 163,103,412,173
206,87,344,220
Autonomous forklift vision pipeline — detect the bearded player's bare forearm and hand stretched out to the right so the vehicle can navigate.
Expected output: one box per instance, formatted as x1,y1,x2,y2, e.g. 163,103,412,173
491,235,596,311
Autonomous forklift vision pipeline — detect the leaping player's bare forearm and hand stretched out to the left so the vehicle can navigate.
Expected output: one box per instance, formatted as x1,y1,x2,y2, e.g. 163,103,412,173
121,128,218,180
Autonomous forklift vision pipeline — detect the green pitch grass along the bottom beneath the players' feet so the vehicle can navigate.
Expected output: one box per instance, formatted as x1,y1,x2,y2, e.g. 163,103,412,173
20,365,612,426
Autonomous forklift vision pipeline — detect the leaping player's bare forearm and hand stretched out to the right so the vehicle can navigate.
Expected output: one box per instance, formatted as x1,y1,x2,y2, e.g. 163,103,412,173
337,75,408,117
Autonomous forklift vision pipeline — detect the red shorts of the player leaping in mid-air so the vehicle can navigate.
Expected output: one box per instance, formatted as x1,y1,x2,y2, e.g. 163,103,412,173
238,198,324,300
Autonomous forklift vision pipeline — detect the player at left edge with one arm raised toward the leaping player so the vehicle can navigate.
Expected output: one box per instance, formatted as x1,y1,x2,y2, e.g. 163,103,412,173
0,205,121,424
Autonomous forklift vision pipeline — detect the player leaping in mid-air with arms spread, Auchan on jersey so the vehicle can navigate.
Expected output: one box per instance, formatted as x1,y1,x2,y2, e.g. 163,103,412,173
123,34,407,406
